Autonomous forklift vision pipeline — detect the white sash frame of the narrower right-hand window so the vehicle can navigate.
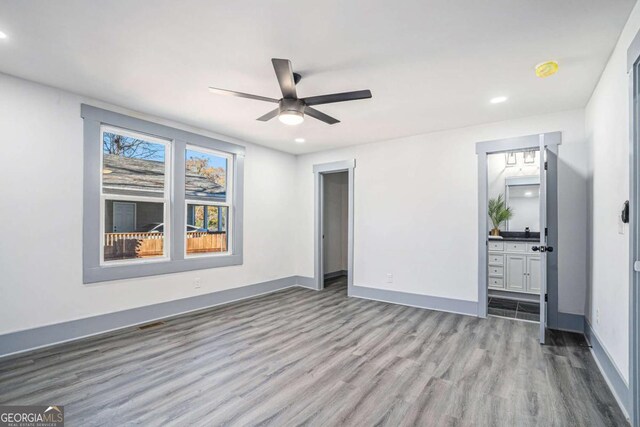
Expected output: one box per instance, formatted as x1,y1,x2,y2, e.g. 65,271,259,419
183,144,235,259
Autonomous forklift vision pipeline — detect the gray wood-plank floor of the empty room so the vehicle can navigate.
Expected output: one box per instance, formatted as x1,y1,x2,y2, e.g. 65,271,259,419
0,282,626,427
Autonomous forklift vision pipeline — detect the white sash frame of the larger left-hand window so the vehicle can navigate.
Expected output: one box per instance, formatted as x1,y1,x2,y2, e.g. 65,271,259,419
97,125,173,267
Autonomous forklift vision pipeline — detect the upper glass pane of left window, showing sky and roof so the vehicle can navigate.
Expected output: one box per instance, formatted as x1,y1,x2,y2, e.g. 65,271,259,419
102,131,165,197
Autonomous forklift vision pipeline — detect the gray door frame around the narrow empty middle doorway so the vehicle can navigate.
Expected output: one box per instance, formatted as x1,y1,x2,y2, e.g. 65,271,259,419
313,159,356,296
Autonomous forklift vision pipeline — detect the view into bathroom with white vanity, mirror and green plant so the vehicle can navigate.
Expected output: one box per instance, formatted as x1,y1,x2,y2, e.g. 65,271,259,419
485,149,541,322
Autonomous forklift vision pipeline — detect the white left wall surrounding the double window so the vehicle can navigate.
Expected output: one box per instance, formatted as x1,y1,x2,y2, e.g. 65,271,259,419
0,74,296,334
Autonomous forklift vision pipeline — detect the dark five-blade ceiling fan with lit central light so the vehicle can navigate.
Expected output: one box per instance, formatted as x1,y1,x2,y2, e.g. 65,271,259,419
209,58,371,125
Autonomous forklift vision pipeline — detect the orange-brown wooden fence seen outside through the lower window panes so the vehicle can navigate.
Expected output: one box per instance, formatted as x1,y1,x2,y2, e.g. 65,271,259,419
104,231,227,261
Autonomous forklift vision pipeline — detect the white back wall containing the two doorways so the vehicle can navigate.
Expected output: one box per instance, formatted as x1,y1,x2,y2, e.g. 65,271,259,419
296,110,587,314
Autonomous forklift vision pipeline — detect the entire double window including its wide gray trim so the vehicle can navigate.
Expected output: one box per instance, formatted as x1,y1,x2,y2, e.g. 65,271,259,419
82,105,244,283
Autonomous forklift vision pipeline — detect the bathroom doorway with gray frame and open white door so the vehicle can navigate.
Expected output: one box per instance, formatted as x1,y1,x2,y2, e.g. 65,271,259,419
476,132,561,344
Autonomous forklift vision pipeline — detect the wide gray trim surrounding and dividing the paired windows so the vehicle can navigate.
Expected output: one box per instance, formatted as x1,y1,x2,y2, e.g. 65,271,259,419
81,104,245,284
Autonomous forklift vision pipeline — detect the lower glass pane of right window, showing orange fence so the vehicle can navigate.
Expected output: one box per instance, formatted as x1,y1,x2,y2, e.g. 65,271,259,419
187,204,229,254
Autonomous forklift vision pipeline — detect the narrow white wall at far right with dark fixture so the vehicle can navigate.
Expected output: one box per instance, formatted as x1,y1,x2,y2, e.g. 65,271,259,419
585,0,640,380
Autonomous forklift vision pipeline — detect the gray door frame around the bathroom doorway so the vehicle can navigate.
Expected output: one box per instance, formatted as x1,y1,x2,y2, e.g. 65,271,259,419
476,132,562,320
